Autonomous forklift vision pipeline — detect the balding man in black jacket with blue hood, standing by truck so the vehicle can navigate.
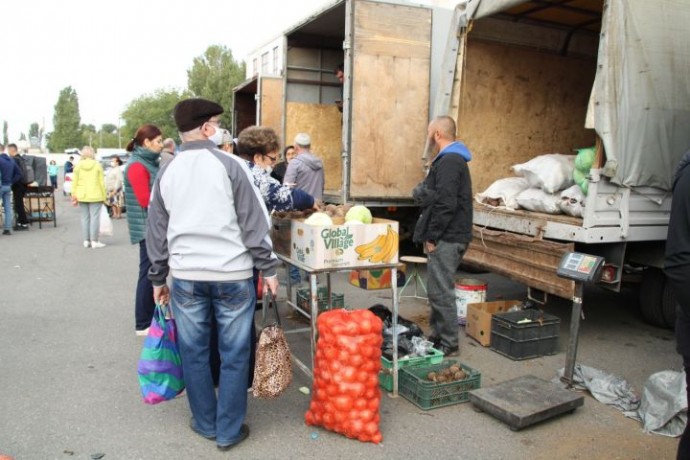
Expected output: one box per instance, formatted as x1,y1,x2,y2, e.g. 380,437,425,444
412,116,472,356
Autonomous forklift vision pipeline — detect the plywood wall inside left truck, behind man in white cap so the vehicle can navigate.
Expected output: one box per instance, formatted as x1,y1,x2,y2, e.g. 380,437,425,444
285,102,343,194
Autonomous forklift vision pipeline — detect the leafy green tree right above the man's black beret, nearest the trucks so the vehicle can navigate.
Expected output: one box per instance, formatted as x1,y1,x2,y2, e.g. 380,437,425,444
187,45,245,128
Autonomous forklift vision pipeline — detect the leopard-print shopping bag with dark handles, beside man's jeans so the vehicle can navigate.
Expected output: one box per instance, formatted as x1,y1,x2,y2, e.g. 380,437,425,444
252,291,292,399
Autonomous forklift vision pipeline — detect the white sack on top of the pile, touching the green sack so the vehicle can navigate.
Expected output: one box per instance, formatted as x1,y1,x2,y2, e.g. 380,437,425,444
512,153,575,193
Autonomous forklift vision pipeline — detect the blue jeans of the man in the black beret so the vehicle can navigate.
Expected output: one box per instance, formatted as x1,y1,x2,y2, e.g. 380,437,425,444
171,278,256,445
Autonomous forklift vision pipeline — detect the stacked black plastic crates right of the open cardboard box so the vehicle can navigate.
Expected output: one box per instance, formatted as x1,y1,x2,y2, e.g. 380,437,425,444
491,310,561,361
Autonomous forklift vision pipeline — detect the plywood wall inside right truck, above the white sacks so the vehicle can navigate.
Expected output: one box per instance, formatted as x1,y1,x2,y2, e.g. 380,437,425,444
458,39,596,192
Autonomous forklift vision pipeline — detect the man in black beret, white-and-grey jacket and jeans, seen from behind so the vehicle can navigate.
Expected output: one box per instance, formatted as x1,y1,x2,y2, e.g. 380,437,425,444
146,99,279,450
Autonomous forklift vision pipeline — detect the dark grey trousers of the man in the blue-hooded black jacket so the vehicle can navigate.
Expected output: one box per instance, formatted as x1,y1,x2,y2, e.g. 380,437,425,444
427,241,467,347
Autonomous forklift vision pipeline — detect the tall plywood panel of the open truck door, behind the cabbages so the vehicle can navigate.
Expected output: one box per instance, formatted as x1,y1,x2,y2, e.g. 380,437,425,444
350,1,431,199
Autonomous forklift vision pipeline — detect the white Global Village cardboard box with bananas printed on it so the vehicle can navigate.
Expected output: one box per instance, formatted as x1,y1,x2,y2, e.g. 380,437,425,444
290,218,399,269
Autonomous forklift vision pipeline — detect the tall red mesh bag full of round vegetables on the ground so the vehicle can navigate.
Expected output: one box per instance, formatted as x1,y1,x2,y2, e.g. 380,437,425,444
304,309,383,444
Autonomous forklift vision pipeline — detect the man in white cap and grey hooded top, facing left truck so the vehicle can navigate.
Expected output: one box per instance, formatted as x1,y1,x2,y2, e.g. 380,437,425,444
283,133,324,200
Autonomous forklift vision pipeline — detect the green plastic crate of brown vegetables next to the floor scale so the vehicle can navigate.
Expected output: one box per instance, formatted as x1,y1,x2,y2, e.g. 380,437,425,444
399,359,481,410
